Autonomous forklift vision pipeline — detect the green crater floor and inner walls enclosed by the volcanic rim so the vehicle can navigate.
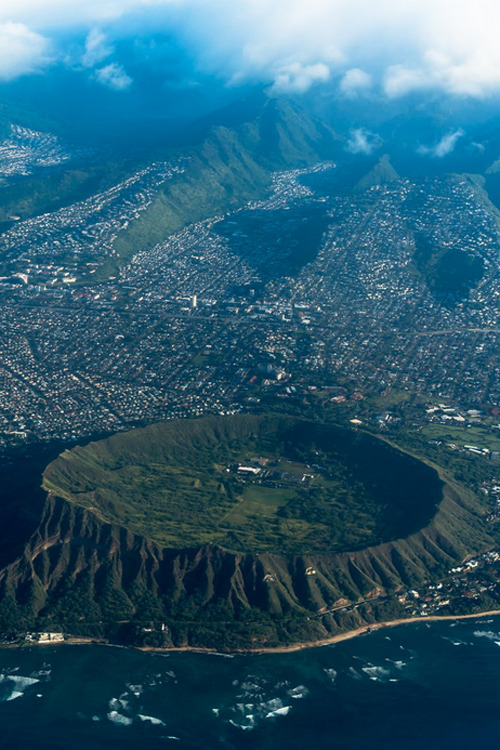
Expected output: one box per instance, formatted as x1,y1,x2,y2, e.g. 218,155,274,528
43,415,443,555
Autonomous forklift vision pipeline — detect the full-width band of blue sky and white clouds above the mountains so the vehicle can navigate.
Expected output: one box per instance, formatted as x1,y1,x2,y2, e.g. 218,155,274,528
0,0,500,100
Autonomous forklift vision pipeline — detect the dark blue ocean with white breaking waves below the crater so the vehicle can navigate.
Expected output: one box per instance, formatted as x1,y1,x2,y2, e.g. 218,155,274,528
0,618,500,750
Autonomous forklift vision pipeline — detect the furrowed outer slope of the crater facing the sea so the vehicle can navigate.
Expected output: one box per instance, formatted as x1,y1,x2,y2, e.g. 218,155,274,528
0,488,491,648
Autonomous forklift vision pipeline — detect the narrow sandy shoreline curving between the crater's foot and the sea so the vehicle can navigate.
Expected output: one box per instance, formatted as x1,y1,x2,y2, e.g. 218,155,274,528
5,609,500,656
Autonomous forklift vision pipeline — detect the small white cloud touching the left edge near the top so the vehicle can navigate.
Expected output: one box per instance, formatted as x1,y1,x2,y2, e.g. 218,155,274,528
0,22,50,81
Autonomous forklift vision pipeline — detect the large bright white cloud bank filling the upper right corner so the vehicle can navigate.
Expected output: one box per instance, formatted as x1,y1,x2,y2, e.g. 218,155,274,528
159,0,500,97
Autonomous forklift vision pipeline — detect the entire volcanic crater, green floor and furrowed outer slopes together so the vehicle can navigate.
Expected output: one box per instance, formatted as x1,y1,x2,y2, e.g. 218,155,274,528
0,413,495,649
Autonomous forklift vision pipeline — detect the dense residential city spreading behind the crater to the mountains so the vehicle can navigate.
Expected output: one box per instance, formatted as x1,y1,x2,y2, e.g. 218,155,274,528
0,162,500,447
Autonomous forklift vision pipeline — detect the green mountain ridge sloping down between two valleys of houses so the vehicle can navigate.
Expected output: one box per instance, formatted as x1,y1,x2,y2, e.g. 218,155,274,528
111,99,340,262
